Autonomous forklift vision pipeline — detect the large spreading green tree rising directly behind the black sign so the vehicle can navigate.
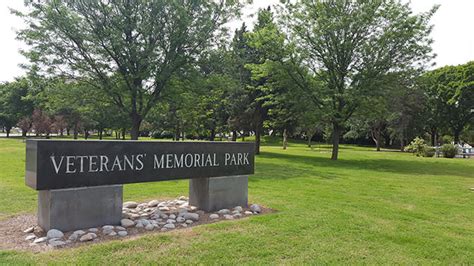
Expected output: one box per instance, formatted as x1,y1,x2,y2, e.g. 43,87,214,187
15,0,241,140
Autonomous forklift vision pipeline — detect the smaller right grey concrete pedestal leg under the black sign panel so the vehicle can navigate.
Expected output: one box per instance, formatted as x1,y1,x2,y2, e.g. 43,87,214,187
189,175,248,212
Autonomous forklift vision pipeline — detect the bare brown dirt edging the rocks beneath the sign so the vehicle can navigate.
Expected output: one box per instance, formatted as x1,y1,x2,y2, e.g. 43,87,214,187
0,205,274,253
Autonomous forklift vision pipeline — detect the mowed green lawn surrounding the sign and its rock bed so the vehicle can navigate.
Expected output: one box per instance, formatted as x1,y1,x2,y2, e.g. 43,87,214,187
0,139,474,264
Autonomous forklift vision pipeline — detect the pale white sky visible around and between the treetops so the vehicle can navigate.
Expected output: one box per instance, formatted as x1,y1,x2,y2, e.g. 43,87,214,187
0,0,474,82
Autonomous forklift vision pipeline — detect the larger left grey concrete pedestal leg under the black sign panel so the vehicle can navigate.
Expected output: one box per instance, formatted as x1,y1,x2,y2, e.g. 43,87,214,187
38,185,123,231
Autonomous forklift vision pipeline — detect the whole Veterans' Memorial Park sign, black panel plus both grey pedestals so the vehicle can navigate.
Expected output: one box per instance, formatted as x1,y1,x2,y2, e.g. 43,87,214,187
25,140,255,231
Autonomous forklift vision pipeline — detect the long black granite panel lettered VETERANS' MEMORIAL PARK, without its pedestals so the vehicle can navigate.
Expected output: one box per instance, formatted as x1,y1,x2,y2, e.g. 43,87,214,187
26,140,255,190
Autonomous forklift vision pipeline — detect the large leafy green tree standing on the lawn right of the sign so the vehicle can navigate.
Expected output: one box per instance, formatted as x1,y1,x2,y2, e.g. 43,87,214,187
283,0,436,160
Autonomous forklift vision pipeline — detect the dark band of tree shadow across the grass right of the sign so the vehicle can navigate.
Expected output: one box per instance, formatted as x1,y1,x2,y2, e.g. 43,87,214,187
257,151,474,179
